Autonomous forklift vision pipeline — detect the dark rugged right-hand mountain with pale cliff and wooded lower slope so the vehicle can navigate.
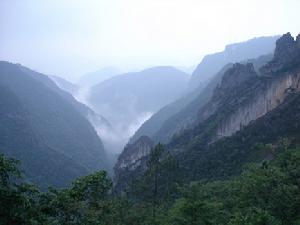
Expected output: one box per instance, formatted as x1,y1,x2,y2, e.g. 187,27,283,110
115,33,300,188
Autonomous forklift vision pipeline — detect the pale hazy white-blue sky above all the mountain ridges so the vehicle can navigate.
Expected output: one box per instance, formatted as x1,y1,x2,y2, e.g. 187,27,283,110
0,0,300,78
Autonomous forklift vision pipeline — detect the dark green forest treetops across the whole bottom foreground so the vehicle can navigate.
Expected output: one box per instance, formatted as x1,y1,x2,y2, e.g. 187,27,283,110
0,140,300,225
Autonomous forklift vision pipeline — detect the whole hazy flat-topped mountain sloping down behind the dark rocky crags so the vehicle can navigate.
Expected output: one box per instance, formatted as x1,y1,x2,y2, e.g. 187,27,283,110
130,36,278,143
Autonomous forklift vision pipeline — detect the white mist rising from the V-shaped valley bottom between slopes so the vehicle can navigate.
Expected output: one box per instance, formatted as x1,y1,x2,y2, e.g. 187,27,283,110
74,87,153,156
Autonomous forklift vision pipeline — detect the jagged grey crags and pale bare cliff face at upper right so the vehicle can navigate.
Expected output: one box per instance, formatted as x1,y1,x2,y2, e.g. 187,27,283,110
199,33,300,140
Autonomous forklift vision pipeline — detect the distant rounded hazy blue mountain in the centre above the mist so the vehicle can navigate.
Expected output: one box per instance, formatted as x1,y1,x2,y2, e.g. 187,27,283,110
90,67,189,122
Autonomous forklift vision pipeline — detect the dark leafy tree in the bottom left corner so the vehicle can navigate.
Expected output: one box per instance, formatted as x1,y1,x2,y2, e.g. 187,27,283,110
0,154,42,225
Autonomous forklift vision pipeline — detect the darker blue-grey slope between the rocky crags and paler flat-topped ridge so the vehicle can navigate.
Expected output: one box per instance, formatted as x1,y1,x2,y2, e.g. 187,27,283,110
130,54,272,143
